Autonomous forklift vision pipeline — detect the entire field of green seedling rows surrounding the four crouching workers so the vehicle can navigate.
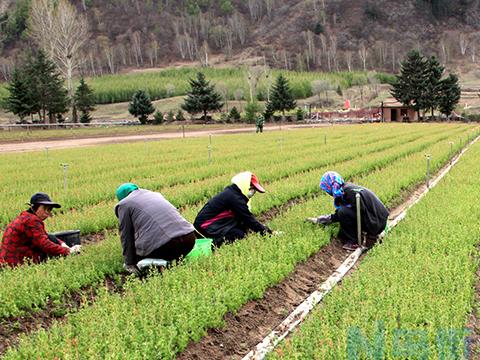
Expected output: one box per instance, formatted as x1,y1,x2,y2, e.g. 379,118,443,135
0,124,480,359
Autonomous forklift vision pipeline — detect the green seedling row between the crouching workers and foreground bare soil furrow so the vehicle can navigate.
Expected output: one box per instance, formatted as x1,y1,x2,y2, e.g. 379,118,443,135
5,121,468,359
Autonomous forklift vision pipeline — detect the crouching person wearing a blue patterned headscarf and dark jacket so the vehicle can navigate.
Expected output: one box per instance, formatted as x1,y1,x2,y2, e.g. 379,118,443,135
306,171,388,250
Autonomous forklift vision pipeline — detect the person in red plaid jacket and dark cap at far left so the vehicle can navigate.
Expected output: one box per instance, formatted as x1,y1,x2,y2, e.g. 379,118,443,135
0,193,81,267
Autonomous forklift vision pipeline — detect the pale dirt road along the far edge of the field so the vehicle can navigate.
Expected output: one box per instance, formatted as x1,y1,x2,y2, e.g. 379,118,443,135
0,124,330,153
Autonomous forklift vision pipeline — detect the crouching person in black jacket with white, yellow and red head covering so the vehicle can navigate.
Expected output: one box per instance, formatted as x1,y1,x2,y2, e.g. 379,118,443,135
193,171,272,246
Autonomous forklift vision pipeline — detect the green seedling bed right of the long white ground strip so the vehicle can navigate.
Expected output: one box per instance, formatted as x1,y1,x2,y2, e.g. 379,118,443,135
271,143,480,359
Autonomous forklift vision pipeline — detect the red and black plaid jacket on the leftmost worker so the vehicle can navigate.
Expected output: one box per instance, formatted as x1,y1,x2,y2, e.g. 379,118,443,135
0,211,70,266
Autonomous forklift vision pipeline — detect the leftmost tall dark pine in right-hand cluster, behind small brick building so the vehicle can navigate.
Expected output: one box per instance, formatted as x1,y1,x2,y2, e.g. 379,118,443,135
391,50,428,117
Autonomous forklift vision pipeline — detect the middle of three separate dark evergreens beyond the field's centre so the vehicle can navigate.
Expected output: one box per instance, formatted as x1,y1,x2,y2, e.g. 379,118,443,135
182,72,223,121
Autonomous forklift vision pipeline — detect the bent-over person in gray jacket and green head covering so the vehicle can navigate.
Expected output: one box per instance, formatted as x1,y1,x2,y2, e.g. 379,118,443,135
115,183,196,275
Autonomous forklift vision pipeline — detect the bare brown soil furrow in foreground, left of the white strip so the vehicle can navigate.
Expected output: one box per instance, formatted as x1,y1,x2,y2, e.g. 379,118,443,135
177,238,349,360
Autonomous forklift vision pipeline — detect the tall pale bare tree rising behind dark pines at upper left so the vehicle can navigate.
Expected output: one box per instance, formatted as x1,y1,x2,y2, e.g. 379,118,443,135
29,0,89,121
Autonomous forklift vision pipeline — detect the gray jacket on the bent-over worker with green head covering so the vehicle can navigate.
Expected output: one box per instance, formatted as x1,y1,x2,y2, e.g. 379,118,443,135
115,189,195,265
